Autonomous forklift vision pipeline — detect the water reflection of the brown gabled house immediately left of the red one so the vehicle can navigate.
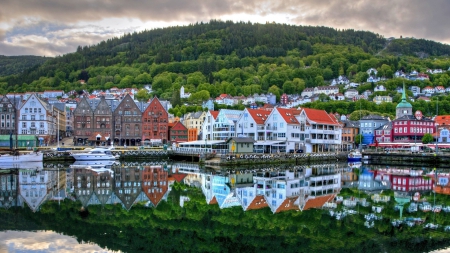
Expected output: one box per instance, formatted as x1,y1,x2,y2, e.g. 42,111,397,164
114,167,142,210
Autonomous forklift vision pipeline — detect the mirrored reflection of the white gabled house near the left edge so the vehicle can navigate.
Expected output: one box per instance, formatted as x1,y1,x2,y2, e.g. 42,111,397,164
19,170,56,212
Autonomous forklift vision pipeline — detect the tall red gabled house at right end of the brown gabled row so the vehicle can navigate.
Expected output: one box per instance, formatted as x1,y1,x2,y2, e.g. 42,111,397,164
142,97,169,143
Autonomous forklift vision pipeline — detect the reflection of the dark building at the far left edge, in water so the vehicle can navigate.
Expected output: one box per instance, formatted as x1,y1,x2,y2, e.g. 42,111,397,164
0,173,23,209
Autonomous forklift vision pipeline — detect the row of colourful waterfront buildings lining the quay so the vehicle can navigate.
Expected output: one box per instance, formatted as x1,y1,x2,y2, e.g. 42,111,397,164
0,83,449,150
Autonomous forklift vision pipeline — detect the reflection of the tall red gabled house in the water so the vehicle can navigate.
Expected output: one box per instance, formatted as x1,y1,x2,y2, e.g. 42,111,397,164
142,166,169,206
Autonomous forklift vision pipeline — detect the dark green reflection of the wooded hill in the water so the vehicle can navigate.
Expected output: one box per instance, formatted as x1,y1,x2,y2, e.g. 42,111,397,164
0,183,450,252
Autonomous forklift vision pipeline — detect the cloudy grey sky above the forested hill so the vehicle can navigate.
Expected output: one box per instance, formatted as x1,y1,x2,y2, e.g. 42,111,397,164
0,0,450,56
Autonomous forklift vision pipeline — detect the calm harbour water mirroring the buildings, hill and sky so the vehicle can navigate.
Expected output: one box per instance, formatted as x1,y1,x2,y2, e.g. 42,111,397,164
0,162,450,252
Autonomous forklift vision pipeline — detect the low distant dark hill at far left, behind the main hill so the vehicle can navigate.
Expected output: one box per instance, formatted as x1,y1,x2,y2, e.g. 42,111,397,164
0,55,50,76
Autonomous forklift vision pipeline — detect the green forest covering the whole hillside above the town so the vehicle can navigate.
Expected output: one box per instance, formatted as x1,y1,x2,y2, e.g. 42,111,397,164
0,20,450,114
